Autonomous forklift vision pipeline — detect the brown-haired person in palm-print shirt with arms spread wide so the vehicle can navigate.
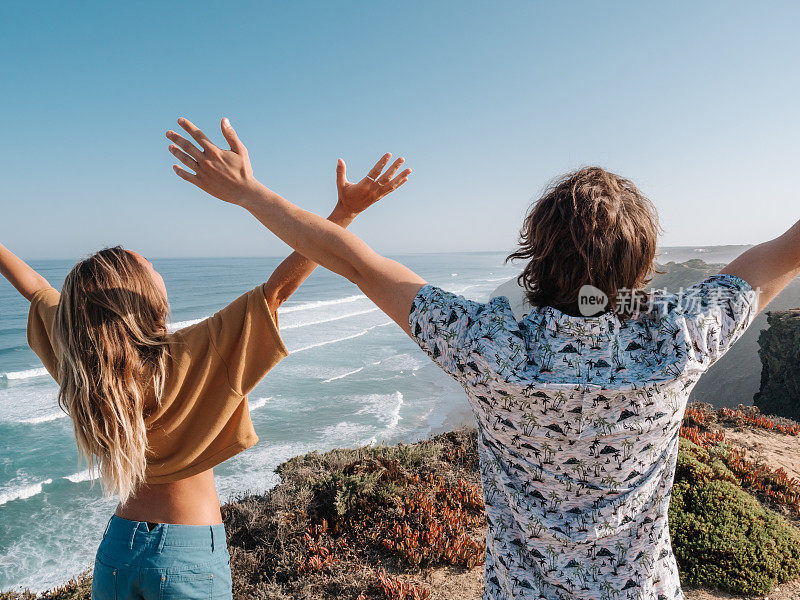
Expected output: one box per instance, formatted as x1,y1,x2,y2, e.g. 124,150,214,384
168,121,800,600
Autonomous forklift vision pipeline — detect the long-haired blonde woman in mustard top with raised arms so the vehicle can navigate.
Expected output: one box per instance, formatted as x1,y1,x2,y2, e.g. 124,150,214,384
0,146,405,600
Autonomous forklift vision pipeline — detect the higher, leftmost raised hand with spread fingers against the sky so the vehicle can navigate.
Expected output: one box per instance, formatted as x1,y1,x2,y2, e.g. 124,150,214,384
167,118,260,204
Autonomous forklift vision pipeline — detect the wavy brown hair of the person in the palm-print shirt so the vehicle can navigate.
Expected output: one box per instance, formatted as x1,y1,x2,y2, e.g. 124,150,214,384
506,167,659,314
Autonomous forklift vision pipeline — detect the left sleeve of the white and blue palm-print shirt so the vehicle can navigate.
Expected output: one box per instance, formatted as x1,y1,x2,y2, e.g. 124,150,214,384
409,285,521,378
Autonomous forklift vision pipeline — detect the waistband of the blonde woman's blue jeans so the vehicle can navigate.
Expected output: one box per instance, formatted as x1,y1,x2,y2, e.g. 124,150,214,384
103,515,227,552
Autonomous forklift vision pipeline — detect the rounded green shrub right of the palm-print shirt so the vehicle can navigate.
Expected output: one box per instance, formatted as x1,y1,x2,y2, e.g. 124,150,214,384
669,440,800,595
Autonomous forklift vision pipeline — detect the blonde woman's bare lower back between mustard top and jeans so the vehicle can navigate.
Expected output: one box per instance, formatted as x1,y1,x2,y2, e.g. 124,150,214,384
115,469,222,525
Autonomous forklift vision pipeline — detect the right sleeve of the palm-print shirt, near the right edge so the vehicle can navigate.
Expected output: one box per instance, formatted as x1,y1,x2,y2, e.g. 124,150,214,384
678,274,758,367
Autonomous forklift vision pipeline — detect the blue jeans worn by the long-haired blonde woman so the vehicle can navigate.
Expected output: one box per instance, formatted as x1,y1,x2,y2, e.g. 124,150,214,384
92,515,232,600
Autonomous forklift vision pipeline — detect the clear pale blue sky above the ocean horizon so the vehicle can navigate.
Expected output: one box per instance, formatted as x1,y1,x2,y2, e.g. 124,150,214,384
0,1,800,258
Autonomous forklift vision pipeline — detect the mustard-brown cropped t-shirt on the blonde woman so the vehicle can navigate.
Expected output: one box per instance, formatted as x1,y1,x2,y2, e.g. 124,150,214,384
28,284,288,483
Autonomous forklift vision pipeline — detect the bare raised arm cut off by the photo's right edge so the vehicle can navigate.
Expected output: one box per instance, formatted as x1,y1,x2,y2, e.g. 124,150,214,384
720,221,800,311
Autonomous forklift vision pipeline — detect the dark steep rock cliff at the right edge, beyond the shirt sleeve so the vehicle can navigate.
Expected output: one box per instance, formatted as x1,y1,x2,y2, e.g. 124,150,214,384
753,309,800,420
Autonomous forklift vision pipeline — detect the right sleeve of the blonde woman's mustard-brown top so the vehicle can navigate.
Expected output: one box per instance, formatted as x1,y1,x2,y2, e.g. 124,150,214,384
207,284,289,396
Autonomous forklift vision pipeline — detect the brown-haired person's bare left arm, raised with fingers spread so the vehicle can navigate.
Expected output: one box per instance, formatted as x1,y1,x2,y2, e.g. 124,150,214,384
170,119,425,333
